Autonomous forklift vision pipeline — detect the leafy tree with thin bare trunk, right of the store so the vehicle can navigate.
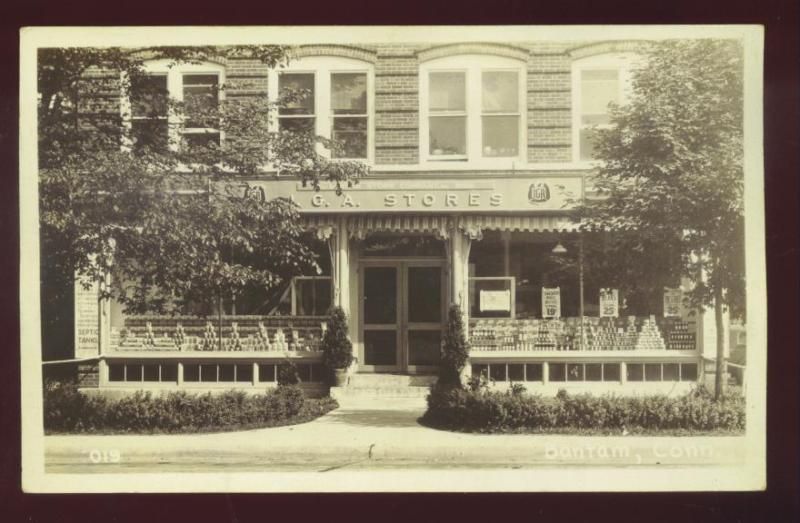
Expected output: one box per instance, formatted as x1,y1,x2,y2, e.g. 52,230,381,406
583,40,744,397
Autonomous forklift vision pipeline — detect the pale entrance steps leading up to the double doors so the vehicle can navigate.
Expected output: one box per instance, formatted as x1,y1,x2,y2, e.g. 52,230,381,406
331,374,436,400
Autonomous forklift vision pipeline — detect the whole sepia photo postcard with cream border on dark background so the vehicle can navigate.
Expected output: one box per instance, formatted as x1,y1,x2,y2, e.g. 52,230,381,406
20,25,767,492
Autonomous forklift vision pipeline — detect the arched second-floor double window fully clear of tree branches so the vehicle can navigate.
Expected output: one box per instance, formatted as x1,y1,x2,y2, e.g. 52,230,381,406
421,56,524,162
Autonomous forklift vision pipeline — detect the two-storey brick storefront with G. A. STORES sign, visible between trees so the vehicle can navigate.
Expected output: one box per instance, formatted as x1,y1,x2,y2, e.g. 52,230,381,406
76,42,713,393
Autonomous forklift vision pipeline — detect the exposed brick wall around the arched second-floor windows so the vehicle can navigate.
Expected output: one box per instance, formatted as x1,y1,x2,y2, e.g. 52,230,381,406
79,41,641,165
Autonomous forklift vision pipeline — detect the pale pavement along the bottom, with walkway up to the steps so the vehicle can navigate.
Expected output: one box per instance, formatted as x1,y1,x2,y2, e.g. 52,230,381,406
45,399,745,473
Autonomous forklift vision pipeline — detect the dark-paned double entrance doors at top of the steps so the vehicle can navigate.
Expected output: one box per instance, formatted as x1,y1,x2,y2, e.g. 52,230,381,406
359,261,445,373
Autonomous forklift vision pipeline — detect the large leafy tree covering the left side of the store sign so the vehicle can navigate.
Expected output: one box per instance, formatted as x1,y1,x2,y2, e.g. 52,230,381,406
38,46,366,360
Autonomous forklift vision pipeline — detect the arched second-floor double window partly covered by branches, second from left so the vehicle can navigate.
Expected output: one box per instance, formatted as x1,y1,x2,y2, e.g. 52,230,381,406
277,57,371,160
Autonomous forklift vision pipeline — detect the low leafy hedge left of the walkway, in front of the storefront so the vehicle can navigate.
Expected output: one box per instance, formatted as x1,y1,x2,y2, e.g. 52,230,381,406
44,382,338,433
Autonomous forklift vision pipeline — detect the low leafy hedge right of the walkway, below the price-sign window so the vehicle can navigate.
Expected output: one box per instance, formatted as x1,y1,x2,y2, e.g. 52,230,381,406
423,386,745,432
